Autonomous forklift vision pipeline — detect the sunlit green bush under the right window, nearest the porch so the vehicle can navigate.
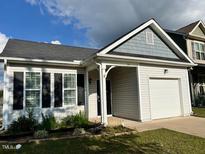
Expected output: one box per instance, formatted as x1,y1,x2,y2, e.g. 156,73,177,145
61,112,89,128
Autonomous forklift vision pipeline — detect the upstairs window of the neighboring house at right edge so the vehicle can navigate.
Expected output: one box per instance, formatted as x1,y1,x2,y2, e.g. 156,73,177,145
192,42,205,60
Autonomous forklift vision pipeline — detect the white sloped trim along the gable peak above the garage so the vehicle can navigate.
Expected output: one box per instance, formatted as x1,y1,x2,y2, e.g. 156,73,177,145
97,19,194,64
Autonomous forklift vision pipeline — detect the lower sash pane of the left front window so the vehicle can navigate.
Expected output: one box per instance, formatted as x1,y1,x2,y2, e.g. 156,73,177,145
26,90,40,107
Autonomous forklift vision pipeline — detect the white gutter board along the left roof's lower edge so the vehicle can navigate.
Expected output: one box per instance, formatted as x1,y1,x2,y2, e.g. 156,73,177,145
0,57,81,65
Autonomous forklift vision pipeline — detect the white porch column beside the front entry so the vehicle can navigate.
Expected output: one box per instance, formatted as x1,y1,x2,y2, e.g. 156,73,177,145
99,64,108,125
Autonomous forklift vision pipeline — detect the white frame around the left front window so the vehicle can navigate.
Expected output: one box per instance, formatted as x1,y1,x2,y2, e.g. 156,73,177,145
23,71,42,109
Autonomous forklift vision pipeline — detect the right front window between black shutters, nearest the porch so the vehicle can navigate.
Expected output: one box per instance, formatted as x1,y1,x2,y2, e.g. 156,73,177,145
63,74,77,105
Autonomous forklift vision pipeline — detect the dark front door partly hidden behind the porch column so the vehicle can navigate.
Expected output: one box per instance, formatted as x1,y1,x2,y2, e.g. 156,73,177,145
97,80,112,115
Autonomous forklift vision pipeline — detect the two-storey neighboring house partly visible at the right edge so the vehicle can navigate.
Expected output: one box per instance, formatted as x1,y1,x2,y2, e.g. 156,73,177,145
167,21,205,106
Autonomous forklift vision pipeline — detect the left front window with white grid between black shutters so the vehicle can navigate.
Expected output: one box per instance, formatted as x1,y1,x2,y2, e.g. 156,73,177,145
25,72,41,107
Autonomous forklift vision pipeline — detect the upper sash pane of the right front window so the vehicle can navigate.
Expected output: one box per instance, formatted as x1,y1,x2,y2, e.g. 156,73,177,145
64,74,76,88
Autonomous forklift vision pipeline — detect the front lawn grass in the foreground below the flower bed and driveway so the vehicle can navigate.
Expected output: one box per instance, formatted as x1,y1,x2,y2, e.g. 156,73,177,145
0,129,205,154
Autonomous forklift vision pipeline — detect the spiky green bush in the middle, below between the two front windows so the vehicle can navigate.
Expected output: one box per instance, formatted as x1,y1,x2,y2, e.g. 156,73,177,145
38,114,58,131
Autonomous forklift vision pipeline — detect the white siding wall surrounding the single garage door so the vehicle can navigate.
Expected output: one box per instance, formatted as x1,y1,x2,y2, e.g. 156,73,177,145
139,64,192,121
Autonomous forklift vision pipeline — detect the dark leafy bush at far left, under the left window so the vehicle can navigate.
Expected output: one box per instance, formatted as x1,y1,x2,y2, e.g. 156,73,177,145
8,110,38,134
